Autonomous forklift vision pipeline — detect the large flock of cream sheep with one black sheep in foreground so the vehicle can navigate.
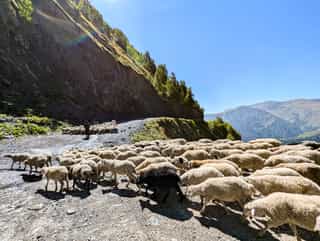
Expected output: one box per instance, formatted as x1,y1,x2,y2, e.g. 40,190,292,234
5,139,320,240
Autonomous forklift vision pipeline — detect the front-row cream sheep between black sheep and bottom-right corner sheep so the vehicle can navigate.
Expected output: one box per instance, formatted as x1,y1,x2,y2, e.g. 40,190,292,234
187,177,258,213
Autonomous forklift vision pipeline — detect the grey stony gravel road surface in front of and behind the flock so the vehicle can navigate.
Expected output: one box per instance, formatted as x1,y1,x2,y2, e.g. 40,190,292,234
0,121,319,241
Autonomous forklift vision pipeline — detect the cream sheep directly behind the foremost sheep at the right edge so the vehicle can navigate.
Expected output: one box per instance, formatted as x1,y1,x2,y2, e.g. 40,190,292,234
245,175,320,195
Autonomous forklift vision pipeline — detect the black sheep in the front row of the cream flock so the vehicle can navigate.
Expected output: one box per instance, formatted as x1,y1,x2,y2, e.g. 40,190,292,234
136,171,185,203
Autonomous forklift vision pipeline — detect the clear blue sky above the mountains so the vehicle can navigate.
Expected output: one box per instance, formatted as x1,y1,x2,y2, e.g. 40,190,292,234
91,0,320,113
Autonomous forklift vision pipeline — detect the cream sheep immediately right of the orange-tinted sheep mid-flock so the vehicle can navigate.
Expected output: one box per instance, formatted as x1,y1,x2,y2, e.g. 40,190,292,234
226,153,265,171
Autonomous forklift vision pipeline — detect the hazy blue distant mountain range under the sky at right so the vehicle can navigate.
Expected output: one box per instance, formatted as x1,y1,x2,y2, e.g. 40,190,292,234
205,99,320,141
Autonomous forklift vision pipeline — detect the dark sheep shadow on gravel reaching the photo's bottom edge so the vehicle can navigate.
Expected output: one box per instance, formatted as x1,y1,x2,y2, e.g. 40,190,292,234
194,205,279,241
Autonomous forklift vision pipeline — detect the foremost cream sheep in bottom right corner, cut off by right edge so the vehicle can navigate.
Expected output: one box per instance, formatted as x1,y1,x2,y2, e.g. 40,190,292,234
243,193,320,241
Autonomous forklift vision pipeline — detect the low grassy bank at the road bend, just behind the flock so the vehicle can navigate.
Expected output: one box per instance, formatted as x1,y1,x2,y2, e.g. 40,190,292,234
132,117,241,142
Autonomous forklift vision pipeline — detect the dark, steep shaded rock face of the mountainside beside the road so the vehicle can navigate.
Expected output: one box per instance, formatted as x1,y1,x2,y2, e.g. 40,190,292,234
0,0,202,122
